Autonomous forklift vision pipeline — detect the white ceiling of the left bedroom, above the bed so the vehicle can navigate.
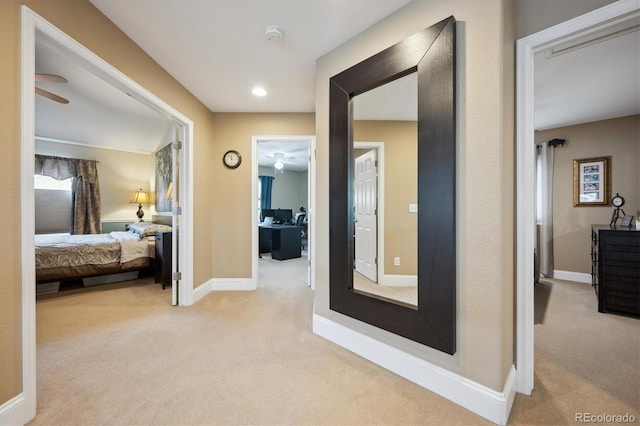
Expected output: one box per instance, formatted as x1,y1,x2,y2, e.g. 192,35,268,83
35,37,170,153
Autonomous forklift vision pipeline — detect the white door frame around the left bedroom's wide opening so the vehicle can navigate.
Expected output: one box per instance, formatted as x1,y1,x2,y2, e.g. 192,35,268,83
20,6,193,423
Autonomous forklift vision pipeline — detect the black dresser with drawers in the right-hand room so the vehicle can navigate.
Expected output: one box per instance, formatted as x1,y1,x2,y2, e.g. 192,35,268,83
591,225,640,318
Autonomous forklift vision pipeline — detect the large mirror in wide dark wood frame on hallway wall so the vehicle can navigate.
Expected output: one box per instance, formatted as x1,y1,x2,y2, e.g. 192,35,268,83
329,16,456,354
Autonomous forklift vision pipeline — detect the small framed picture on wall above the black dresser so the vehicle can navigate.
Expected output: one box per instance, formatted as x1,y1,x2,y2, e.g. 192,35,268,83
573,157,611,207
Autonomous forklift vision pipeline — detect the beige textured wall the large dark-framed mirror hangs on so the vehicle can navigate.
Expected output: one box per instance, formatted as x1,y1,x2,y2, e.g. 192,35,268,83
315,0,514,391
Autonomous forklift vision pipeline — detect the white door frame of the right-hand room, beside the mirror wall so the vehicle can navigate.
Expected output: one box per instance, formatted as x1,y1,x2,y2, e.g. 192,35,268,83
516,0,640,395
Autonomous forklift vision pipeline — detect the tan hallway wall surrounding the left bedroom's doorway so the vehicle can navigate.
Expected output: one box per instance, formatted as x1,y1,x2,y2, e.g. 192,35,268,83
0,0,214,404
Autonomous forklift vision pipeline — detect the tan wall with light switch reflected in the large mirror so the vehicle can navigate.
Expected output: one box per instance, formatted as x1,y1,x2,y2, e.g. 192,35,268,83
353,121,418,275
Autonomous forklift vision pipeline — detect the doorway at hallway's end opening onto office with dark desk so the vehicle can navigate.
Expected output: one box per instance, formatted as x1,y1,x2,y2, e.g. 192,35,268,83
251,135,315,289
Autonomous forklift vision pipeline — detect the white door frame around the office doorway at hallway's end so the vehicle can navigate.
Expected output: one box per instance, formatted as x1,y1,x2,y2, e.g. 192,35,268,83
251,135,316,290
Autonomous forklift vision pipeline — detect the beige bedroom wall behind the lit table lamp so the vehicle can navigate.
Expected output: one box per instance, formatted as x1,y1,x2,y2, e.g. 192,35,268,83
36,140,155,222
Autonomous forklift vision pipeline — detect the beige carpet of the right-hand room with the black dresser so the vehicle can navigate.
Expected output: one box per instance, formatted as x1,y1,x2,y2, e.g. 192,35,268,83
510,279,640,425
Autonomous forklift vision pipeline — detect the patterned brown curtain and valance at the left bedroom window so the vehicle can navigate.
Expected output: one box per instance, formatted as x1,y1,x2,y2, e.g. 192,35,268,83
35,154,102,234
